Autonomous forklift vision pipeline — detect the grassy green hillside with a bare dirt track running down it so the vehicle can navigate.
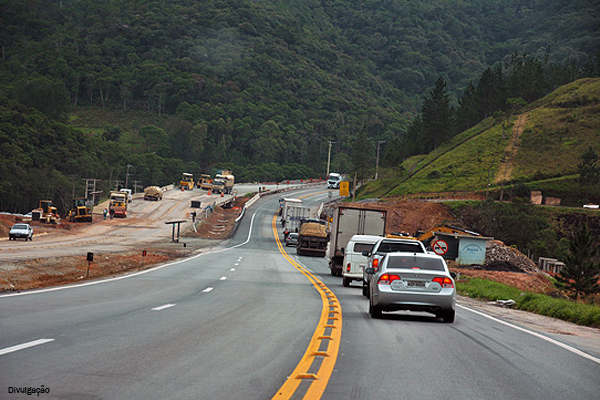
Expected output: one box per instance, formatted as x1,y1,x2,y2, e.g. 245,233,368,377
361,79,600,205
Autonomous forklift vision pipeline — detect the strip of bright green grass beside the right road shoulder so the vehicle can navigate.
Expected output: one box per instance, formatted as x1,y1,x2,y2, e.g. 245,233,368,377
456,277,600,328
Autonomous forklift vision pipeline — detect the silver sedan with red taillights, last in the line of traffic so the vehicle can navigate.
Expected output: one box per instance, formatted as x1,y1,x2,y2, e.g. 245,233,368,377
367,253,456,322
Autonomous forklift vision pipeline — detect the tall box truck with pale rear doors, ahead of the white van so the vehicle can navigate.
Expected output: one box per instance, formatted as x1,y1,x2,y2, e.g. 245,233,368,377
329,205,387,276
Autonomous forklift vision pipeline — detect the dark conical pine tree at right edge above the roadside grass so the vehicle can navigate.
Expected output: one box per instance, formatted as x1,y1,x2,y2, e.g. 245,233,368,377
556,225,600,300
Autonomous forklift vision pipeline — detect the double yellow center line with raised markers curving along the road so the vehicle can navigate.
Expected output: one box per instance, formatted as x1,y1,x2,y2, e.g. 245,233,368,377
272,215,342,400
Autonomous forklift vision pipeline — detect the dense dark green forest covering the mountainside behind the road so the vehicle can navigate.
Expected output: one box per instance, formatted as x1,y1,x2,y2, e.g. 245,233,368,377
0,0,600,211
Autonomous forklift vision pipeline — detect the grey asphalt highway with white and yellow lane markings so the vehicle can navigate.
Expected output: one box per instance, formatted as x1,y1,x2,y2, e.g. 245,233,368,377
0,188,600,400
